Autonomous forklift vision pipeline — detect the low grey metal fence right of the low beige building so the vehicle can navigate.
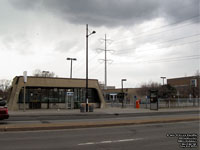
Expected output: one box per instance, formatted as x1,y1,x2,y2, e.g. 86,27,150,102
107,98,200,109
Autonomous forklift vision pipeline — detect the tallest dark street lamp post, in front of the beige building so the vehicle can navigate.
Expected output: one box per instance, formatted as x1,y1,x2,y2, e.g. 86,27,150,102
85,24,96,112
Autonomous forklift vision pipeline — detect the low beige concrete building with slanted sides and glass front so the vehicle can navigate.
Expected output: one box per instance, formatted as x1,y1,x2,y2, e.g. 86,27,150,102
8,76,105,110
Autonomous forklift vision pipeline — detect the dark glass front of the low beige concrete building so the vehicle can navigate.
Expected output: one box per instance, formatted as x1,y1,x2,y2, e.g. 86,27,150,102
18,87,100,106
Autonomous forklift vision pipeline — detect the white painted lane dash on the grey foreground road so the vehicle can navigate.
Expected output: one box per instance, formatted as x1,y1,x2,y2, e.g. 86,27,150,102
78,138,143,146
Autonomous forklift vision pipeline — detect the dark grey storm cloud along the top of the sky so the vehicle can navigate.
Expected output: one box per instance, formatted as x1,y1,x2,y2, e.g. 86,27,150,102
10,0,199,26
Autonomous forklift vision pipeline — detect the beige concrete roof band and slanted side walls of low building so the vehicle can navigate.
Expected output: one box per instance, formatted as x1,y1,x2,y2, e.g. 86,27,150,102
8,76,105,110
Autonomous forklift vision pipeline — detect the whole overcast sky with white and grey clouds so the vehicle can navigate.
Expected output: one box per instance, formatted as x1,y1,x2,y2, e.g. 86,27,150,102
0,0,200,87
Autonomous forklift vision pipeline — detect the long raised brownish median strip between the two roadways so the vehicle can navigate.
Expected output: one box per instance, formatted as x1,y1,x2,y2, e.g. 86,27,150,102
0,117,200,132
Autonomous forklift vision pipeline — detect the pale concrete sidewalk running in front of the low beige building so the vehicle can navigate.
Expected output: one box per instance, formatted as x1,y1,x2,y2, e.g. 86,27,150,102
9,107,200,116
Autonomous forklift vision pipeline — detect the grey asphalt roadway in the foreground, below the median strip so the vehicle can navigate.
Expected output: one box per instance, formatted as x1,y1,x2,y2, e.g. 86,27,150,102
0,121,199,150
